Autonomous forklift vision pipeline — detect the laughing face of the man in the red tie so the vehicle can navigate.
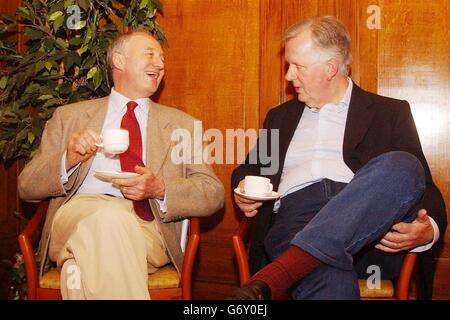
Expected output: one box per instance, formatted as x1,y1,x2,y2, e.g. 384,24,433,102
113,32,164,99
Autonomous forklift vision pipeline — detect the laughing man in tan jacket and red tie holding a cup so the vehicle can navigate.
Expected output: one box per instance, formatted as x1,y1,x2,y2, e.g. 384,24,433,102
19,30,225,299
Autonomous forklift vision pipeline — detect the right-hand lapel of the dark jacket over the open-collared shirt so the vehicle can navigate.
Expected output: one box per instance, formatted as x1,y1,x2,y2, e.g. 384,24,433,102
343,84,375,153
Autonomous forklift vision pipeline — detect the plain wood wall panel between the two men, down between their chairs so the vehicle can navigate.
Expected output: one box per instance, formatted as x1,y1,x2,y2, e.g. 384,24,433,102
159,0,260,299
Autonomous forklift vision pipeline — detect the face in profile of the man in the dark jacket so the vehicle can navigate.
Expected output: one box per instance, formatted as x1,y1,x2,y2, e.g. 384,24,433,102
285,32,329,108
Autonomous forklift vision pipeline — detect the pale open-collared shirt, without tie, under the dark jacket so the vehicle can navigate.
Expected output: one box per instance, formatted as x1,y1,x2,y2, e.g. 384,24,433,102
274,78,440,252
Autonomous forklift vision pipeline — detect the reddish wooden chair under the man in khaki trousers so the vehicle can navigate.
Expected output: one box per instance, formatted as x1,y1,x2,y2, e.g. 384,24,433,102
18,202,200,300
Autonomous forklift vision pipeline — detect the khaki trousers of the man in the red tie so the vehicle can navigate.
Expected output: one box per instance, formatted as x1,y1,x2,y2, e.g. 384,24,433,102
49,194,170,299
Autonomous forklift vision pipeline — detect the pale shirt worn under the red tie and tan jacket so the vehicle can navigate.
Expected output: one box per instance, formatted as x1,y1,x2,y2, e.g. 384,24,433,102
61,88,167,212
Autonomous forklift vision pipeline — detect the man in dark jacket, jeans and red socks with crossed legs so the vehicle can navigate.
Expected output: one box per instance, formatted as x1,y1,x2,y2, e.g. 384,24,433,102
232,17,447,299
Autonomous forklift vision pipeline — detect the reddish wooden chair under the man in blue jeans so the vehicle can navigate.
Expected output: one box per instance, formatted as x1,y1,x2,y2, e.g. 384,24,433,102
233,217,417,300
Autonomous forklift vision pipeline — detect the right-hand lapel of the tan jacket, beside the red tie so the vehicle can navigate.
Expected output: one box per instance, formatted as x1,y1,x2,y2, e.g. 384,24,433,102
146,101,171,175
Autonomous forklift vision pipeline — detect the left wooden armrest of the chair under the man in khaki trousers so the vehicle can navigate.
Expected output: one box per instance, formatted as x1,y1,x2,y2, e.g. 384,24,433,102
18,202,48,300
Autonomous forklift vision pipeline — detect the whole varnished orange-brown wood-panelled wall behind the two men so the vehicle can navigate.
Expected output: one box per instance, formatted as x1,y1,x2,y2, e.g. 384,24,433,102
0,0,450,299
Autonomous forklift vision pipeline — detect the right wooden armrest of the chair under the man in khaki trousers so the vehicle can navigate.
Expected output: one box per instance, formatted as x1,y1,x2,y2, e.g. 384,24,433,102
181,217,200,300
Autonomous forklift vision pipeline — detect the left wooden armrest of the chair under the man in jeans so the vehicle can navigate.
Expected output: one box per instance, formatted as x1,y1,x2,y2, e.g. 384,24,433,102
232,217,253,286
